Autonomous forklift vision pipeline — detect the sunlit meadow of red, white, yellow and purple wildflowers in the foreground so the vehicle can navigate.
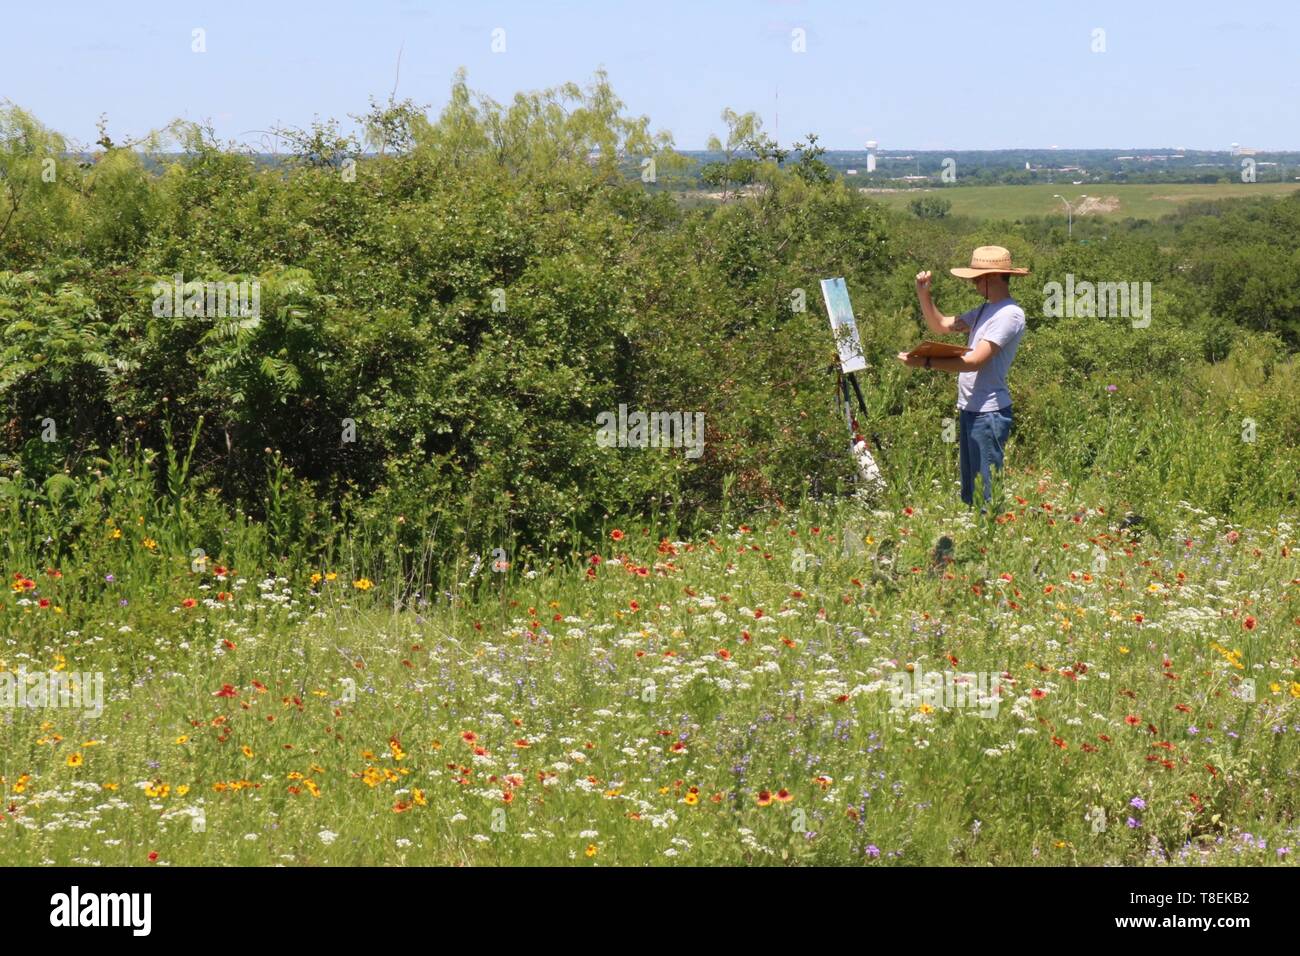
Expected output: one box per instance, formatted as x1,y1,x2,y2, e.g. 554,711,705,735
0,463,1300,866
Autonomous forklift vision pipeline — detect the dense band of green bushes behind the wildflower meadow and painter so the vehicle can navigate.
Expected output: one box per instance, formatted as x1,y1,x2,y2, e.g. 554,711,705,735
0,83,1300,588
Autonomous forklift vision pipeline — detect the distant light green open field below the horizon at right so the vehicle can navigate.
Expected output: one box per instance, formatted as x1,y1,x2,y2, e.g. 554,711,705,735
868,182,1300,220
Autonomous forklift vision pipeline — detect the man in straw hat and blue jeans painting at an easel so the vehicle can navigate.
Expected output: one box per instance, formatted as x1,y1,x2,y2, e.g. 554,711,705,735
898,246,1030,505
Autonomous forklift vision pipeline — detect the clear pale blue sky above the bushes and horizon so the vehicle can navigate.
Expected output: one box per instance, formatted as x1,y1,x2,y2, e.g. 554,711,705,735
0,0,1300,150
